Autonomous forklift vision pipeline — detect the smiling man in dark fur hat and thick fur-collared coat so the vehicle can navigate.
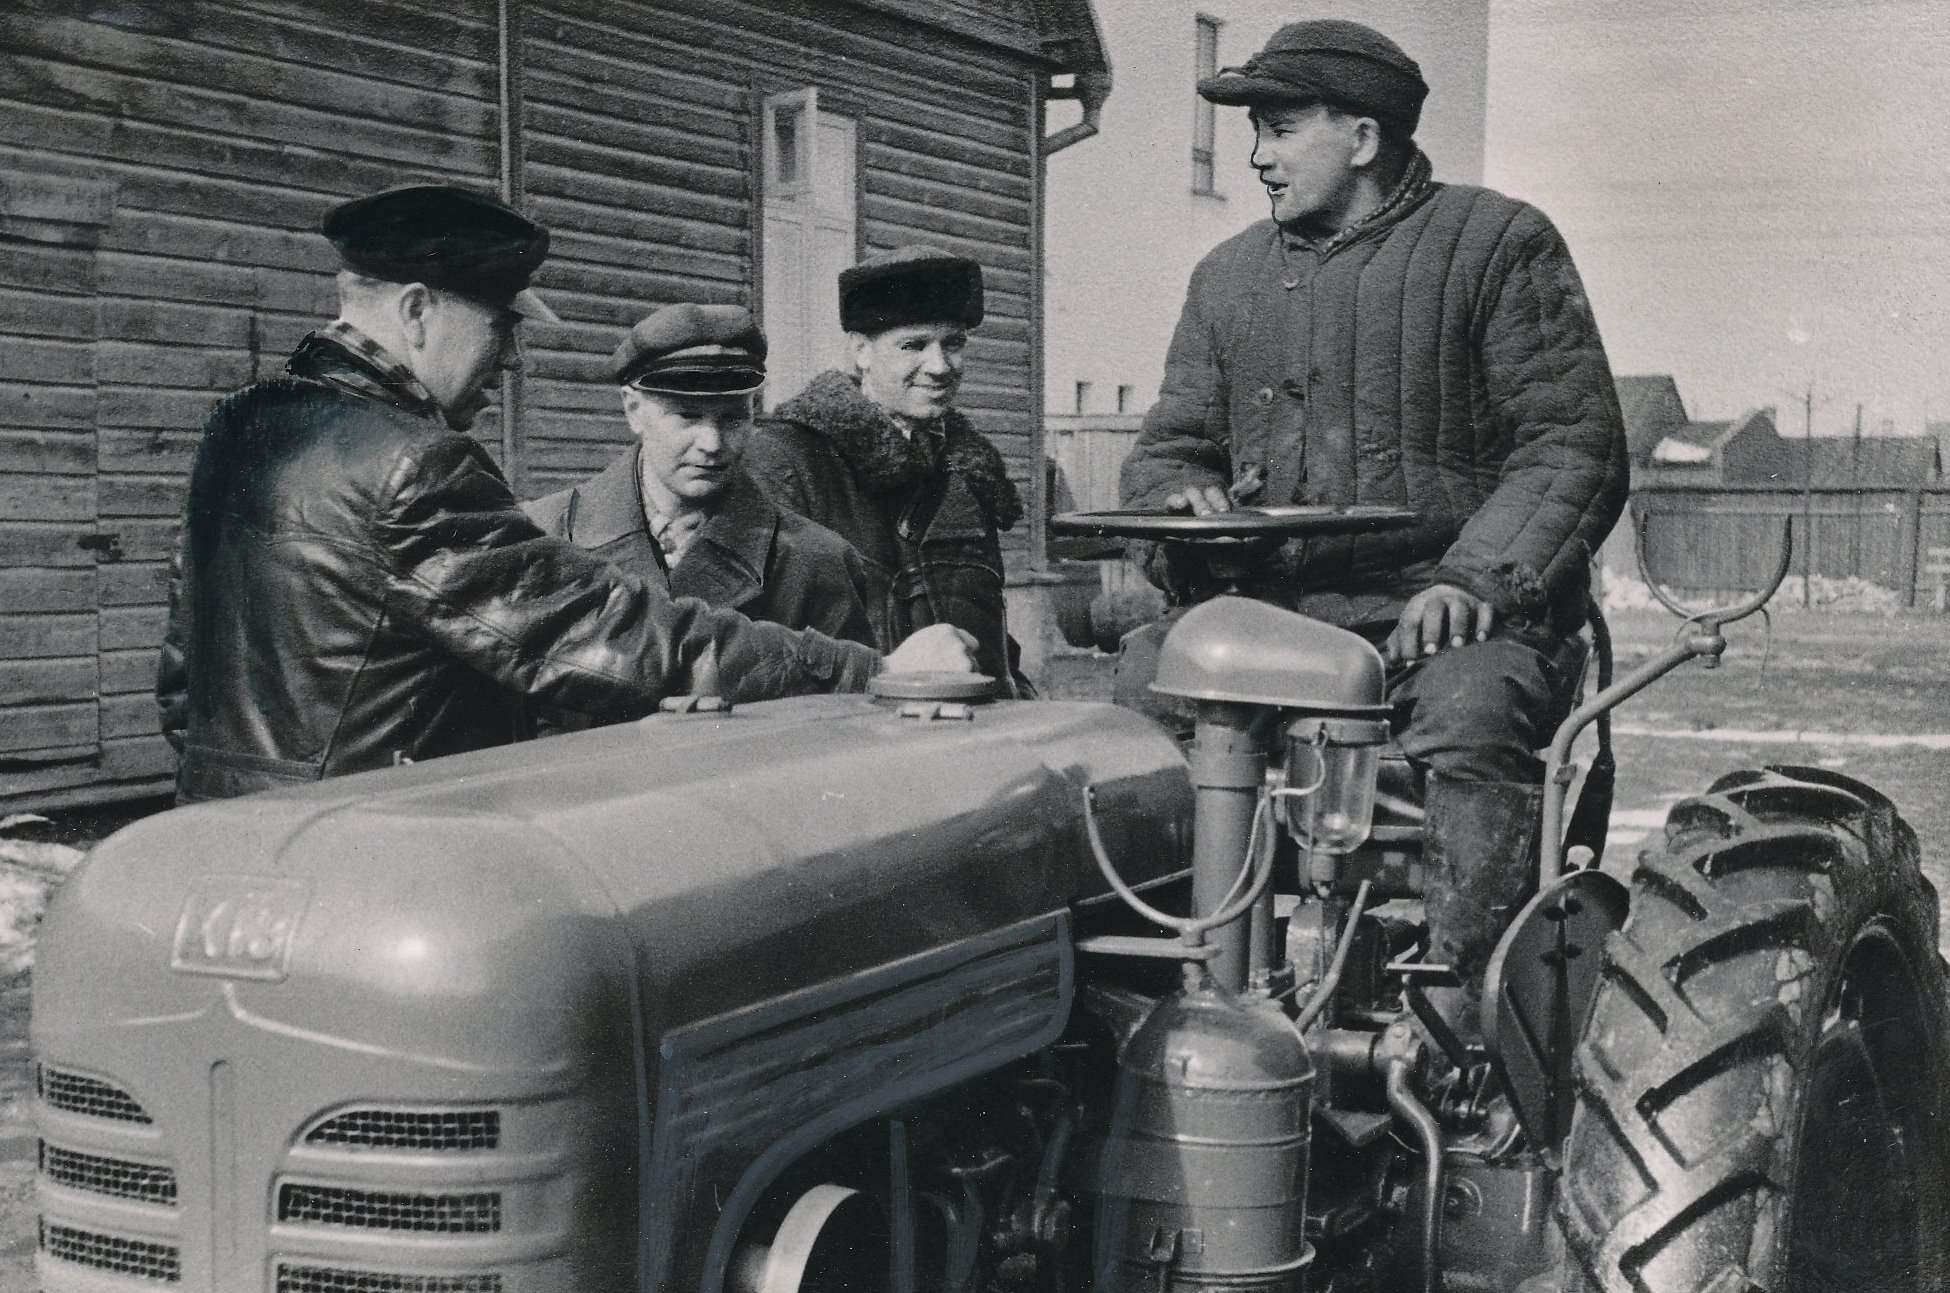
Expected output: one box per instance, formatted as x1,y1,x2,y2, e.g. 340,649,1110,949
745,246,1032,696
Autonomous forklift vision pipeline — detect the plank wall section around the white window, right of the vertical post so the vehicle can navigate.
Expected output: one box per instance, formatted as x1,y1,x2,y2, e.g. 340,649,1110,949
523,0,1035,530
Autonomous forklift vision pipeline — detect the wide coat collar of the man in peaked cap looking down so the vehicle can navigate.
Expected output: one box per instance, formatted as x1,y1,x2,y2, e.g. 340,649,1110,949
571,445,778,607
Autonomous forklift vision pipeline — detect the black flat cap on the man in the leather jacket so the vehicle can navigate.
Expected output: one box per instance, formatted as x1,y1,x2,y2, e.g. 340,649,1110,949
320,183,560,324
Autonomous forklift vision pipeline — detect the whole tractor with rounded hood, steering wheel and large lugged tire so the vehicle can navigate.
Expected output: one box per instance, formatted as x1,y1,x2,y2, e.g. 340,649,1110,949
33,507,1950,1293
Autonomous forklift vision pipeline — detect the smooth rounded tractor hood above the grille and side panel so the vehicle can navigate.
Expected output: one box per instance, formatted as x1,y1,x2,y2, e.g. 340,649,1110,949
37,696,1191,1073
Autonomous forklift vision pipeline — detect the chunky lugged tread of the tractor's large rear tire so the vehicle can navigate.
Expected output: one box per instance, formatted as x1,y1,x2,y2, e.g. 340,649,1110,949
1558,768,1942,1293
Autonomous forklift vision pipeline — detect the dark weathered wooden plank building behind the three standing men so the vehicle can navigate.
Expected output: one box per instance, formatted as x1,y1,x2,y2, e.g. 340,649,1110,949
0,0,1108,805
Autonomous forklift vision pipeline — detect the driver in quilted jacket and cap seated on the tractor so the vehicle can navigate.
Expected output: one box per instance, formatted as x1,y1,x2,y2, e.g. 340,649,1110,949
1123,20,1626,1028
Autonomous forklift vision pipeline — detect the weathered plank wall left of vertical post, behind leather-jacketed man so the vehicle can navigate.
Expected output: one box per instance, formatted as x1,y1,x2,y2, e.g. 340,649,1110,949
0,0,499,803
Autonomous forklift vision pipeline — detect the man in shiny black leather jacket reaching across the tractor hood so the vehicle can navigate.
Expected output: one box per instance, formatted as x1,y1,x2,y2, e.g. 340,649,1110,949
156,185,967,800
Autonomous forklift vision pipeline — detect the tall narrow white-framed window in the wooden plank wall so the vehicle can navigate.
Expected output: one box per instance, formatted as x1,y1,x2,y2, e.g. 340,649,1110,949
759,88,858,408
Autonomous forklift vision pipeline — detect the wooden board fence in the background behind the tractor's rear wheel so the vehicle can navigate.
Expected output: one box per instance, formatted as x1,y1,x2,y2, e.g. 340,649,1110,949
1607,486,1950,607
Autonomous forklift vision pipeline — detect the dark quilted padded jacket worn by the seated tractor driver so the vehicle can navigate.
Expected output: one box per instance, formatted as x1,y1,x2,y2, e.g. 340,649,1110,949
1123,164,1626,630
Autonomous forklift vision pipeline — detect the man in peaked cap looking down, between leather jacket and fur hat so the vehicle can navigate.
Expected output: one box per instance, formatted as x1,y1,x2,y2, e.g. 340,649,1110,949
525,304,874,694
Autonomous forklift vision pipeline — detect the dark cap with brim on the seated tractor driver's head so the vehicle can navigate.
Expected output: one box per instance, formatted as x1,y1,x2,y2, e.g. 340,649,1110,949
1199,18,1429,135
